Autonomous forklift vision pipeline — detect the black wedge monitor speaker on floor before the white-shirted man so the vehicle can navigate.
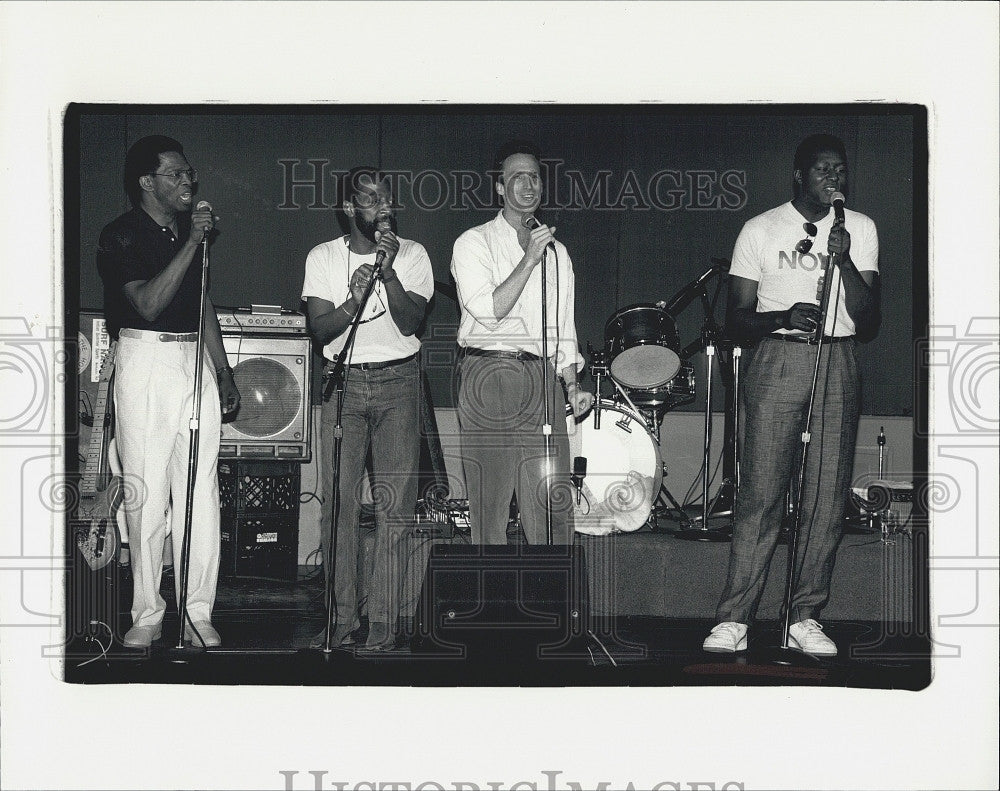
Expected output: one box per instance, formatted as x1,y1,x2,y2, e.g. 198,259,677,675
412,544,589,661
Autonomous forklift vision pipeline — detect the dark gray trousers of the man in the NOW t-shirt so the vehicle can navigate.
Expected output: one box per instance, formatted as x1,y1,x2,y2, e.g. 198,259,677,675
716,338,860,623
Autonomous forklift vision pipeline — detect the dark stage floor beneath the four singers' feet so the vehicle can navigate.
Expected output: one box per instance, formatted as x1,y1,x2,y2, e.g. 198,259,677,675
65,548,931,690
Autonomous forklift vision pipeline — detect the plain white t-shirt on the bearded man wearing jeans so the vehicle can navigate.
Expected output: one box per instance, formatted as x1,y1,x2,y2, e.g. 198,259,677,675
302,236,434,363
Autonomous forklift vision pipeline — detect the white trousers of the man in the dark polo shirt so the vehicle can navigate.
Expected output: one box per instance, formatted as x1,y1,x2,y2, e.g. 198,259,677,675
114,330,222,626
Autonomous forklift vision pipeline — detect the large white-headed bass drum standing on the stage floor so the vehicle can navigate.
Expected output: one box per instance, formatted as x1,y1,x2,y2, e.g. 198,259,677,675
566,399,663,536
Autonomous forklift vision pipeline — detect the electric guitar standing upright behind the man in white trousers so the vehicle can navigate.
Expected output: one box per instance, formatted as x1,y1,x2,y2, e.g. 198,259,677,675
74,341,124,571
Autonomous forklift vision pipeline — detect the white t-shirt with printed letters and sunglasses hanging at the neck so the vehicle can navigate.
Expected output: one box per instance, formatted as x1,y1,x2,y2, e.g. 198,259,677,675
729,201,878,336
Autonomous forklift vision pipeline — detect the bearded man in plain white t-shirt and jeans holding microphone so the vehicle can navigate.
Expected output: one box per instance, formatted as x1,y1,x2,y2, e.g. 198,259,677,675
302,167,434,651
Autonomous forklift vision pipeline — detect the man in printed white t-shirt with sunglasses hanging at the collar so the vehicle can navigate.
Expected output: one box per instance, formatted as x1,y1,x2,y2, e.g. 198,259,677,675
703,135,879,656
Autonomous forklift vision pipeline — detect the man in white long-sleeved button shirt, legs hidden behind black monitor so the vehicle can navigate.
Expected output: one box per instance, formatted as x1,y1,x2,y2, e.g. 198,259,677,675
451,141,594,544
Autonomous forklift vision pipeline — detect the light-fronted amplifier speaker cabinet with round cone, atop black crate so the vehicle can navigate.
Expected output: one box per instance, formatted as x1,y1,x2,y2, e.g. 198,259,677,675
219,332,312,462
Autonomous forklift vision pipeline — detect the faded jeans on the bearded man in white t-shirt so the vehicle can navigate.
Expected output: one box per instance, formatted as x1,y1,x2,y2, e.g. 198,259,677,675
320,358,420,629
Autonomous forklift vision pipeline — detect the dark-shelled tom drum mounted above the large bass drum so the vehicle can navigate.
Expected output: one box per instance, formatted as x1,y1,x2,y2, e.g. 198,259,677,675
604,304,681,389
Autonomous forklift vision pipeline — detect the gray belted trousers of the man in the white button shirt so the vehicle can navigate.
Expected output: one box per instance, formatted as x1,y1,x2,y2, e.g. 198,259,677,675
458,356,574,544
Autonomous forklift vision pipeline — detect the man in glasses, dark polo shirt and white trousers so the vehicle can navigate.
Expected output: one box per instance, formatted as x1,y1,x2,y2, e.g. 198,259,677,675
97,135,240,648
